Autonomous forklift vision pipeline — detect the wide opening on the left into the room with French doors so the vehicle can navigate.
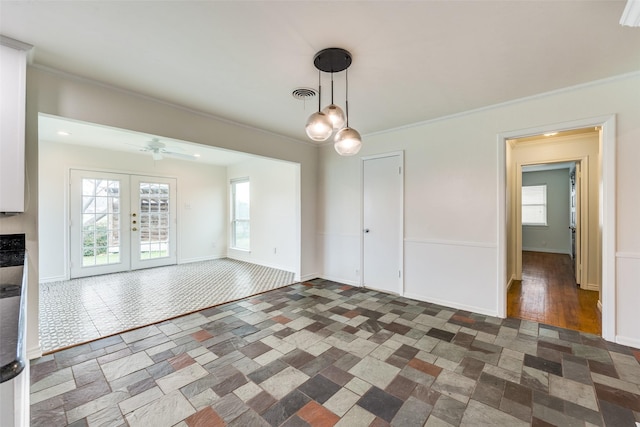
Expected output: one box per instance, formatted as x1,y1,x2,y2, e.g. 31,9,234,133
38,114,301,350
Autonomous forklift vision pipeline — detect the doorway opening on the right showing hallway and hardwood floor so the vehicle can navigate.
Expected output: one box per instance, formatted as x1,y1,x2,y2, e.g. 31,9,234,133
507,127,601,335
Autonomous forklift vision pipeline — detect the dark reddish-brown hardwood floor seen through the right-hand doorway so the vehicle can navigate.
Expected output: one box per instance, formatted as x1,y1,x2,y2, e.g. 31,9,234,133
507,251,602,335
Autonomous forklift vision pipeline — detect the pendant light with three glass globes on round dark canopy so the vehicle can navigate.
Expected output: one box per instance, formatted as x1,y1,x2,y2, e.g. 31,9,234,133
305,47,362,156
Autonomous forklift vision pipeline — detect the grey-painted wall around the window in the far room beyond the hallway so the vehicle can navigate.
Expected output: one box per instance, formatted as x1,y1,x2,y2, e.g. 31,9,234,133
522,169,572,255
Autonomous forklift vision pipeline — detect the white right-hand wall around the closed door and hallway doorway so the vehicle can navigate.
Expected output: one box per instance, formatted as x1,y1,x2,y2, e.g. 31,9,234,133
318,73,640,347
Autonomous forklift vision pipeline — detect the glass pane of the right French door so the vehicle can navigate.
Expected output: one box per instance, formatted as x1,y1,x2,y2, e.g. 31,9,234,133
138,182,171,260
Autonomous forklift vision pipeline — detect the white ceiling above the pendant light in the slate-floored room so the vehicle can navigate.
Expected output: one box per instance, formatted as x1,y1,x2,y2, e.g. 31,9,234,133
0,0,640,143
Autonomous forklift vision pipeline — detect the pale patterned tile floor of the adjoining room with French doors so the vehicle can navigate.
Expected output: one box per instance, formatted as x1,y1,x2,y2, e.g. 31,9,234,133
39,258,294,353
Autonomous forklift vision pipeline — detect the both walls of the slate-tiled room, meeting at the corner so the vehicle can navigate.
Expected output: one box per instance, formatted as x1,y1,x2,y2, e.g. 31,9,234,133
0,67,640,357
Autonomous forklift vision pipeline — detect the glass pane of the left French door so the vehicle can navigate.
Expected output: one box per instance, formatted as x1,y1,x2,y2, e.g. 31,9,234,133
81,178,120,267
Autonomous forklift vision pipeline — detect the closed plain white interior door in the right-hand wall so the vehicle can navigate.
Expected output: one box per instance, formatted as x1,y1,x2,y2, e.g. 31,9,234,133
362,153,404,294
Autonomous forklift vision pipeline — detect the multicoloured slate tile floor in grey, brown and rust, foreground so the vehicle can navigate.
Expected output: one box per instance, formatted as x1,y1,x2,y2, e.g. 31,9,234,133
31,279,640,427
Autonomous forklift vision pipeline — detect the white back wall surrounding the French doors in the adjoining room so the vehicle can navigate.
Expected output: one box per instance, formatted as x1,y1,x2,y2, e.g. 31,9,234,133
38,141,227,282
